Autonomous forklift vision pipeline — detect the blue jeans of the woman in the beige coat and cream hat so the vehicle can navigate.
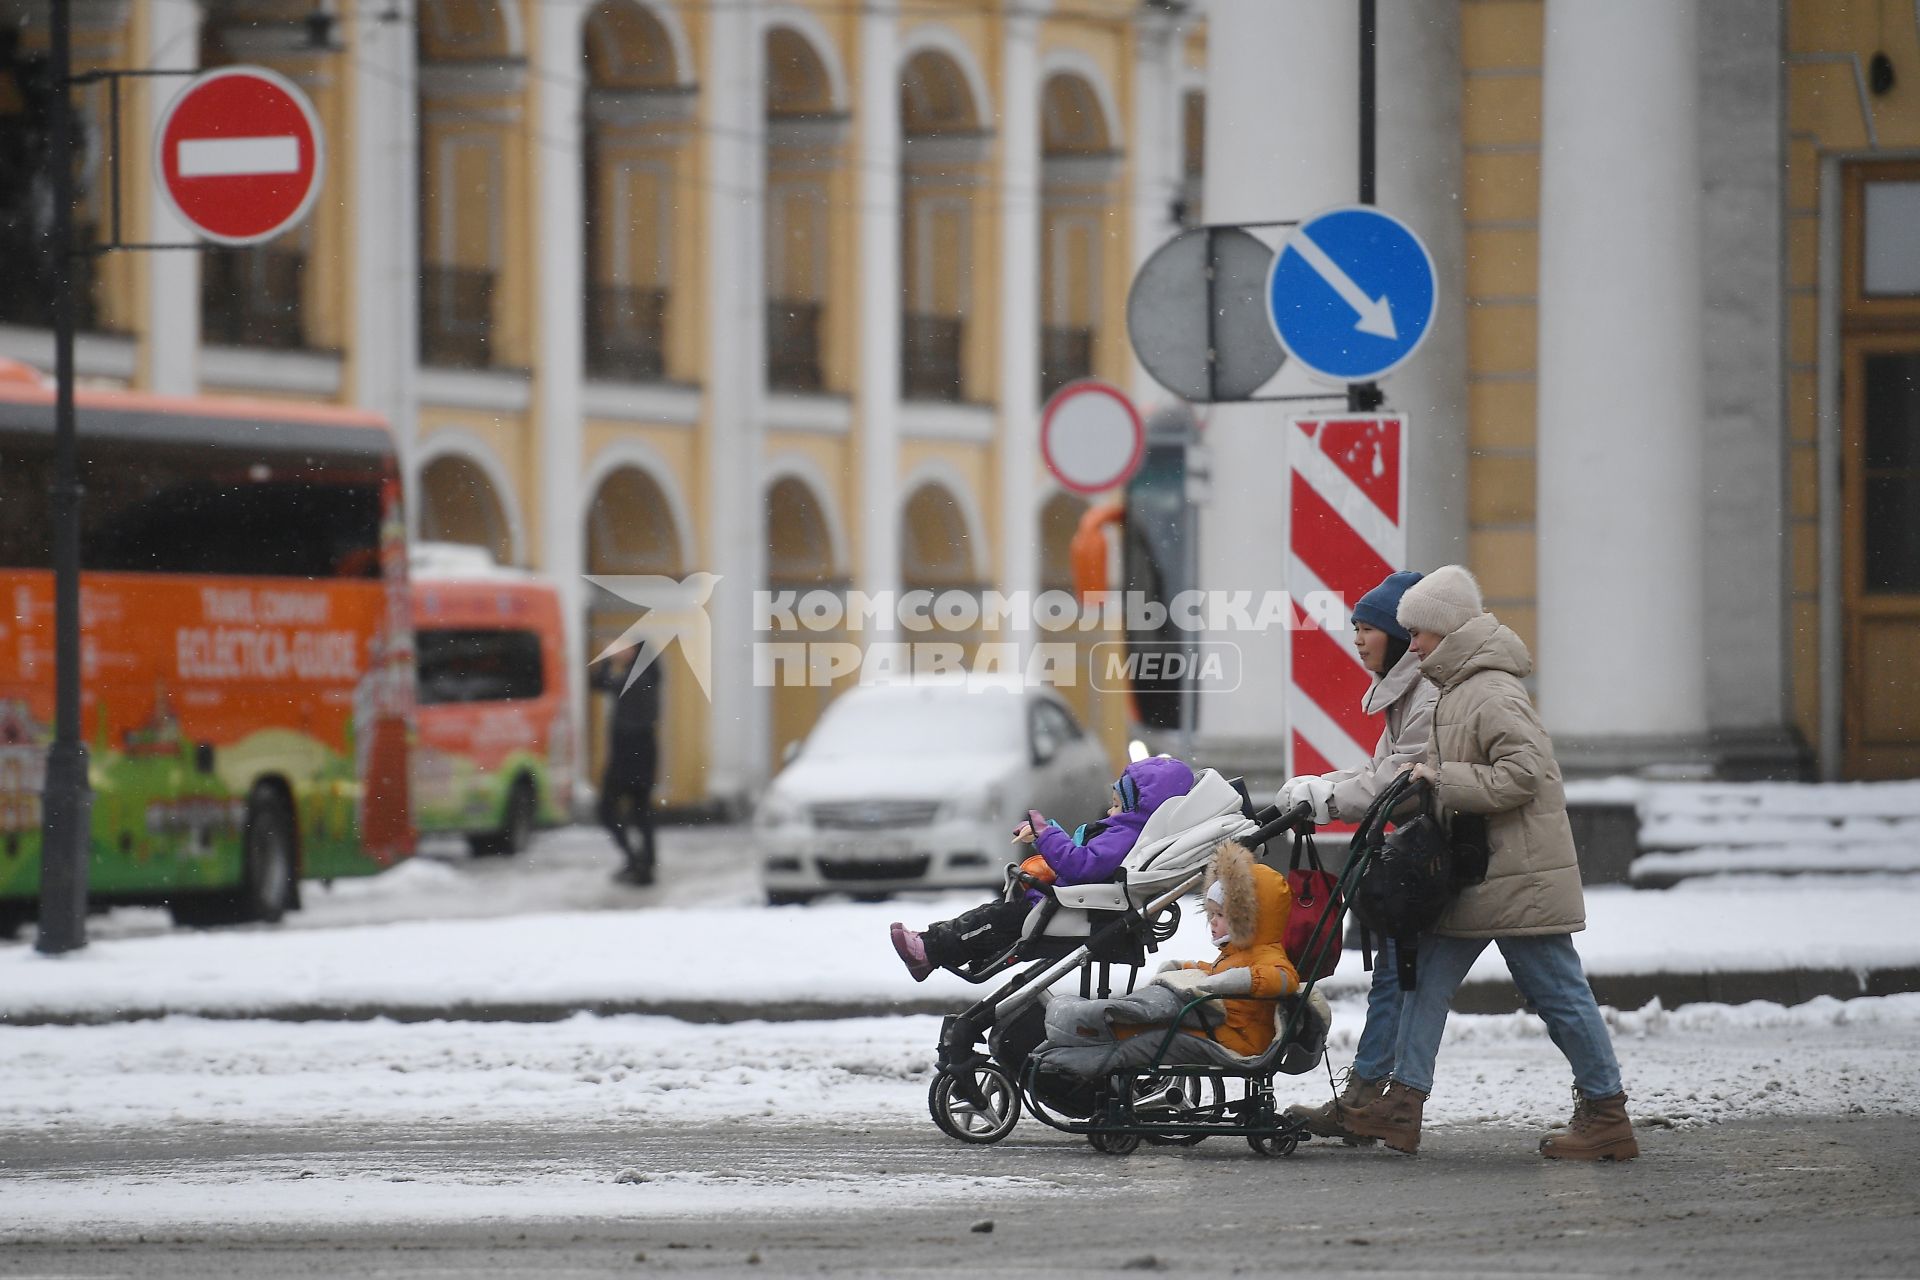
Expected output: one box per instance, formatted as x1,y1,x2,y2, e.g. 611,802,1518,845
1394,933,1620,1098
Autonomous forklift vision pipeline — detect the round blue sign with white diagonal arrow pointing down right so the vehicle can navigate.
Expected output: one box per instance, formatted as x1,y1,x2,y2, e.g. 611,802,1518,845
1267,205,1438,382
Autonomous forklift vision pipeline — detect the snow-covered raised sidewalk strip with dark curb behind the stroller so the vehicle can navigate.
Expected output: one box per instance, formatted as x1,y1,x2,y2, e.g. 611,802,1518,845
0,877,1920,1025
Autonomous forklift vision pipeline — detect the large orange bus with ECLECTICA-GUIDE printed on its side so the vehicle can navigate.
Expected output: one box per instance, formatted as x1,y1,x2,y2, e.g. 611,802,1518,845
0,365,415,936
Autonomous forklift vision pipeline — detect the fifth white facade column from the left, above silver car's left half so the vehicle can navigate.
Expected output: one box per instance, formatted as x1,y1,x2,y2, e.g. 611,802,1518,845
854,6,898,641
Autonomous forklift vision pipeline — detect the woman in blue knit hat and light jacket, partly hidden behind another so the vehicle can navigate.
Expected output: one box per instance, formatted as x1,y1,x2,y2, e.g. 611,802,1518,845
1279,572,1440,1142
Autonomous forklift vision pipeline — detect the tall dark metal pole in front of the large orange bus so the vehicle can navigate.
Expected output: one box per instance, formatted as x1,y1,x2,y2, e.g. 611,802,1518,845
35,0,92,956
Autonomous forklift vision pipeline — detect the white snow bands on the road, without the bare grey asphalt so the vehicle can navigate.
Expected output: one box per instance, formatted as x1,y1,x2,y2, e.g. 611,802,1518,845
0,996,1920,1234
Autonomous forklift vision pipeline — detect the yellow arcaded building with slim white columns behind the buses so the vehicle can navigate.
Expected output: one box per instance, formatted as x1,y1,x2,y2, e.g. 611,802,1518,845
0,0,1204,804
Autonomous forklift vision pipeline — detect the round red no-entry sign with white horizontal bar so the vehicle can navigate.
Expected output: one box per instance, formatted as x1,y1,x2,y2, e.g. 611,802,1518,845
154,67,326,244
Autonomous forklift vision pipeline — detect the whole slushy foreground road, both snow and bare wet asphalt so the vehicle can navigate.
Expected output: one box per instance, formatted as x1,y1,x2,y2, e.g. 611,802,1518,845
0,996,1920,1276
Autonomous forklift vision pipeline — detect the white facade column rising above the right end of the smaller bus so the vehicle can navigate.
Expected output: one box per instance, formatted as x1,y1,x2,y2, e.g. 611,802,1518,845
534,0,588,802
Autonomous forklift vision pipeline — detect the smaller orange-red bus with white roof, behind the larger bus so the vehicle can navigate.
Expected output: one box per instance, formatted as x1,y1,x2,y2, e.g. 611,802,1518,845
411,543,574,856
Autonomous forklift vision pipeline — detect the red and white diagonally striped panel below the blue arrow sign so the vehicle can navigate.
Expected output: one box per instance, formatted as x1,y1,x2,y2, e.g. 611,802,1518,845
1286,413,1407,786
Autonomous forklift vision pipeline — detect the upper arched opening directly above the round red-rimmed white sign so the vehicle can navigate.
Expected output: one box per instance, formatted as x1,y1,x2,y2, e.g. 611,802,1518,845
1041,73,1116,399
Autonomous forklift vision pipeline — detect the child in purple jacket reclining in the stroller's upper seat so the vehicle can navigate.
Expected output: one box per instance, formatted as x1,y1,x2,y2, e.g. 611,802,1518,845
893,756,1194,983
